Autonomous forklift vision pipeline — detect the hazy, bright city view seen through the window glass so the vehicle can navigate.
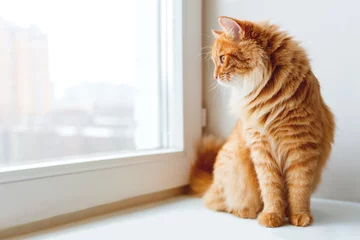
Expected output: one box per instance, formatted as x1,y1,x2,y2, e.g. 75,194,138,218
0,0,160,167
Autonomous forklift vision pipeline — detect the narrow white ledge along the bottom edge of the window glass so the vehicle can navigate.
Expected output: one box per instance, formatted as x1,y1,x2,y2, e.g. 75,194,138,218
0,148,185,184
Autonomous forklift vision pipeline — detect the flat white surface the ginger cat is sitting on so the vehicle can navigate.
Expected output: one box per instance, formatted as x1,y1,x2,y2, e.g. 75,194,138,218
9,197,360,240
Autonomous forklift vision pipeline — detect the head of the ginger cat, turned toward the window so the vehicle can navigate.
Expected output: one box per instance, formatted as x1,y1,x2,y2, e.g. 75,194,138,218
211,17,269,90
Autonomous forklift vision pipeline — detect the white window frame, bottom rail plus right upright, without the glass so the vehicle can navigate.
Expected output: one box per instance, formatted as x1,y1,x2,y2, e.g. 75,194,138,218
0,0,202,229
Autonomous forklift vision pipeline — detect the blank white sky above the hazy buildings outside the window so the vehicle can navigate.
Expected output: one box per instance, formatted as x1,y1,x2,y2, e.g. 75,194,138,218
0,0,136,97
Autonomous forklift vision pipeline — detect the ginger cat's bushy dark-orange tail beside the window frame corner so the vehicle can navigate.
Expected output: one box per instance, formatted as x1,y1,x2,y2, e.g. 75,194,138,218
189,135,224,196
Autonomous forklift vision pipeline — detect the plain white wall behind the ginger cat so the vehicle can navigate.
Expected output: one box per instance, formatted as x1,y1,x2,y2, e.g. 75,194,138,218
203,0,360,202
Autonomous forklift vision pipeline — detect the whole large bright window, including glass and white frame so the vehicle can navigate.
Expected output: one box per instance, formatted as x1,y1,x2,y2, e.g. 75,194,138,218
0,0,201,229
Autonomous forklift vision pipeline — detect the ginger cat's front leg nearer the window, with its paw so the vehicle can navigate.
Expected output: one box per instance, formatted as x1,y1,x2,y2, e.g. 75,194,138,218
248,133,285,227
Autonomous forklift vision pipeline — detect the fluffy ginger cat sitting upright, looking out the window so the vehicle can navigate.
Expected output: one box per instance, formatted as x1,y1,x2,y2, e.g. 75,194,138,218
190,17,335,227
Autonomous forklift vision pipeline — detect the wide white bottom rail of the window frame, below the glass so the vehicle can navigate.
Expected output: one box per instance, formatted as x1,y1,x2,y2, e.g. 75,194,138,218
0,151,191,231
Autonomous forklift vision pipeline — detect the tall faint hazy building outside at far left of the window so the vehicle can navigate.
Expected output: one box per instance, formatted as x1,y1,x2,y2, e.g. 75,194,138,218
0,19,54,125
